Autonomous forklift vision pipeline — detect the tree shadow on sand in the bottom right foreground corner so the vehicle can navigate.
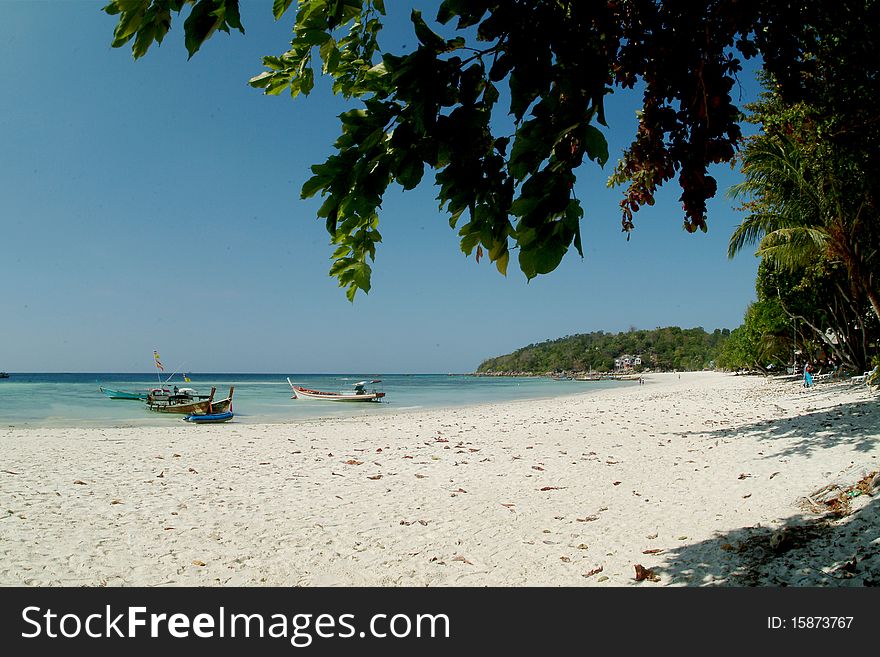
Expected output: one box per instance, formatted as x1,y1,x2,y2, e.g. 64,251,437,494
648,498,880,587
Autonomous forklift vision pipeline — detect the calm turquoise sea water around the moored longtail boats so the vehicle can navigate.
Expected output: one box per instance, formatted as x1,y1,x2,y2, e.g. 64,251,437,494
0,373,632,427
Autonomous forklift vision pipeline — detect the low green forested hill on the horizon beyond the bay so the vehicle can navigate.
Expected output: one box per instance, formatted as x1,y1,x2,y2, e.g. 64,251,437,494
477,326,730,374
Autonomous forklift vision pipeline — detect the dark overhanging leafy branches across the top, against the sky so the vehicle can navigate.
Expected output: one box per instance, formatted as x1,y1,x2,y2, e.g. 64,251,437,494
105,0,876,299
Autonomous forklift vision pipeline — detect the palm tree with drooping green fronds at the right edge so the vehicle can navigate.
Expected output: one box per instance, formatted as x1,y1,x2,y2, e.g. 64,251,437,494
728,134,880,319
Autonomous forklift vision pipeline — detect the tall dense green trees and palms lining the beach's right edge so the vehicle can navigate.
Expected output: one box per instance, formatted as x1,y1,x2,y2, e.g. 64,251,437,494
722,3,880,372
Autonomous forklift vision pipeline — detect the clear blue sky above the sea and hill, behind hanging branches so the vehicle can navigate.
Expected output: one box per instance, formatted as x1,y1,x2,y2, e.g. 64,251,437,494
0,0,757,373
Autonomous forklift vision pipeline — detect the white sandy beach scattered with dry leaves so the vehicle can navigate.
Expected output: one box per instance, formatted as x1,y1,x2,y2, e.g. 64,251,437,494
0,373,880,587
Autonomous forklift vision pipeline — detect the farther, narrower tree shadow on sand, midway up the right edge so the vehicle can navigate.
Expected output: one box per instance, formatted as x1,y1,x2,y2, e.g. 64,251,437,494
680,402,880,458
